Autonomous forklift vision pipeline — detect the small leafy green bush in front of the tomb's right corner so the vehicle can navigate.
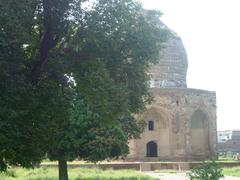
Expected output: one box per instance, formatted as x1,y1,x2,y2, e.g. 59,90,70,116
187,161,224,180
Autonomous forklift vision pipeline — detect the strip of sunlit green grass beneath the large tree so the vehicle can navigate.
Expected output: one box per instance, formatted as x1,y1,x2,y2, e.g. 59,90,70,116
0,167,153,180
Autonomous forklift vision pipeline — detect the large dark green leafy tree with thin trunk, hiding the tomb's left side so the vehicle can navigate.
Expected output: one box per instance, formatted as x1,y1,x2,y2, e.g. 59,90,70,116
0,0,168,180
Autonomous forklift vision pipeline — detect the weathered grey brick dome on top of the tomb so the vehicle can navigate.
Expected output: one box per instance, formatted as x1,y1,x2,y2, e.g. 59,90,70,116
149,35,188,88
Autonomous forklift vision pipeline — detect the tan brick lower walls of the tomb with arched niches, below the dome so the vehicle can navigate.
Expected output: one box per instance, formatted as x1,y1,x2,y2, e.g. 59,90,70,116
128,88,217,161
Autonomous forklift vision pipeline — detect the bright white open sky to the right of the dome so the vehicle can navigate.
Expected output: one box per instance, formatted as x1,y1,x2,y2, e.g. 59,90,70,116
141,0,240,130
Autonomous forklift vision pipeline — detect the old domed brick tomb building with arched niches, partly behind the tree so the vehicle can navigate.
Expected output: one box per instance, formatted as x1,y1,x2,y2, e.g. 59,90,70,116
127,23,217,161
